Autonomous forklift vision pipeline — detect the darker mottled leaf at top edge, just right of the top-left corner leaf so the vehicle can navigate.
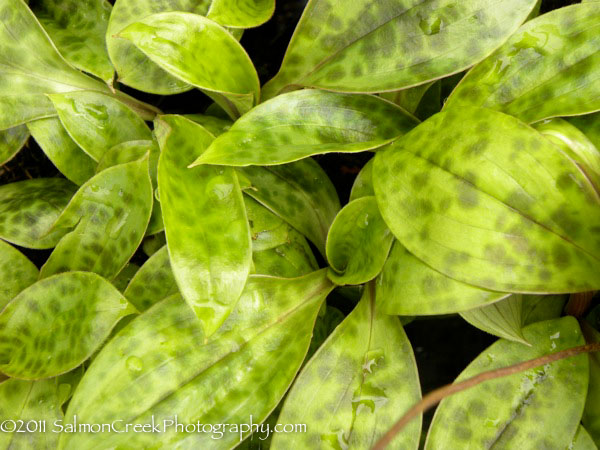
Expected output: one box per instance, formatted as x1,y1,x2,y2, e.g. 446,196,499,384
33,0,114,84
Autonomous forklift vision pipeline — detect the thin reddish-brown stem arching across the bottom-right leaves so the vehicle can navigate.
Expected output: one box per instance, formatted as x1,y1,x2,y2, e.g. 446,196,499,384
373,343,600,450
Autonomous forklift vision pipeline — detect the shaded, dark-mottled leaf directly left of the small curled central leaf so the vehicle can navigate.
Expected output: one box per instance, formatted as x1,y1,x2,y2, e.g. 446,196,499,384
238,158,340,255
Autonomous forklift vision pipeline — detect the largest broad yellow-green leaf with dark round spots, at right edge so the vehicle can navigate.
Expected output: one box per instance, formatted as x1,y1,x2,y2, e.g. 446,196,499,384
373,107,600,293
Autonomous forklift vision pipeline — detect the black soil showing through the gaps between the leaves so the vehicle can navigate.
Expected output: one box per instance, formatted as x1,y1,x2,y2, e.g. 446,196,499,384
0,0,579,436
